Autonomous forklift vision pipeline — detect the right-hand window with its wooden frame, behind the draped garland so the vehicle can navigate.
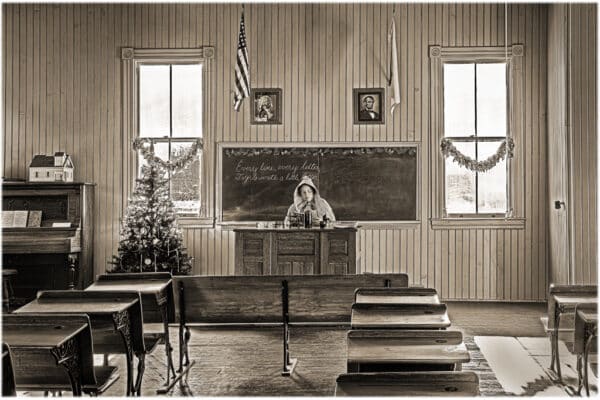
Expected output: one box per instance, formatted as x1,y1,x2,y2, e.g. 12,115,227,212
429,44,524,223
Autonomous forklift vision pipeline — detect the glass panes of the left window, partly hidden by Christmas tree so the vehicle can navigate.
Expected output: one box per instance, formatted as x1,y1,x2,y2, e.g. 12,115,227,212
137,62,203,216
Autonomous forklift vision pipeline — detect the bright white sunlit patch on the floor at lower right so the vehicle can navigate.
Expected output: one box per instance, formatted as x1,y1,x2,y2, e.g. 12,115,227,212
475,336,566,396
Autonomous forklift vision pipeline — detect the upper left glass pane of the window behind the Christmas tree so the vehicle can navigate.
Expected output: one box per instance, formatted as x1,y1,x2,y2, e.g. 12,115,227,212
139,65,169,137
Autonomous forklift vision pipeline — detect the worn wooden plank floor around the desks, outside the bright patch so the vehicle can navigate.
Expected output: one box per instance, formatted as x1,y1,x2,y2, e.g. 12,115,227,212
21,303,556,396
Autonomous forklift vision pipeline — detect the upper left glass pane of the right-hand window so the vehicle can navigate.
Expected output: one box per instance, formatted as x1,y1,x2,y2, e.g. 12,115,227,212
444,64,475,136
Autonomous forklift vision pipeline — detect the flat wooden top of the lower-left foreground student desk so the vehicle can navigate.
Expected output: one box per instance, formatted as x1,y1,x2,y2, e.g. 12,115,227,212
2,323,87,348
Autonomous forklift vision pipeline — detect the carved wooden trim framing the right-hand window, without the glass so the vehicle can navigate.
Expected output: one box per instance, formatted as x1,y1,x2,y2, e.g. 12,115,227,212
429,44,525,229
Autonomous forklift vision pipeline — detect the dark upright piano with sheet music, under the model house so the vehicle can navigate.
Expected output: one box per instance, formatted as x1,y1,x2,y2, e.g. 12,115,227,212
2,181,94,306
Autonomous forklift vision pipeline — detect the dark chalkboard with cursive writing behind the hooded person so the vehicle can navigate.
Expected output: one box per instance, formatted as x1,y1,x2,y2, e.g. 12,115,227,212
220,145,417,221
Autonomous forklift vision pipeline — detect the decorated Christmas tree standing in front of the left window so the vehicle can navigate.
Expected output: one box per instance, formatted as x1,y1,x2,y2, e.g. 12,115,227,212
109,139,197,275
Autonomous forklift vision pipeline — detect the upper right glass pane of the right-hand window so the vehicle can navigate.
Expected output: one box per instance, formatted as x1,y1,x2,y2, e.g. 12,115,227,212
477,63,507,136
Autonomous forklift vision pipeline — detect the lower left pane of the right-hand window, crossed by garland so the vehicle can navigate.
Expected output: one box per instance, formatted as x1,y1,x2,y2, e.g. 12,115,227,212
446,143,476,214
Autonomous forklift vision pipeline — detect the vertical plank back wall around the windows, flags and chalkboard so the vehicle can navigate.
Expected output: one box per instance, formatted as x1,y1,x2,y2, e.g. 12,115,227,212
3,4,547,300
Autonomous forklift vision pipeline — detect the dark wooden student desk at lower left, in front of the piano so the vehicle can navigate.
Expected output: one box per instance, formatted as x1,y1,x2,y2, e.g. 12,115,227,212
2,314,96,396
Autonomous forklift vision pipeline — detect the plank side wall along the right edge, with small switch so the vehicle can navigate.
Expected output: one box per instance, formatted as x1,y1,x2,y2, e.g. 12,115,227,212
548,4,598,283
